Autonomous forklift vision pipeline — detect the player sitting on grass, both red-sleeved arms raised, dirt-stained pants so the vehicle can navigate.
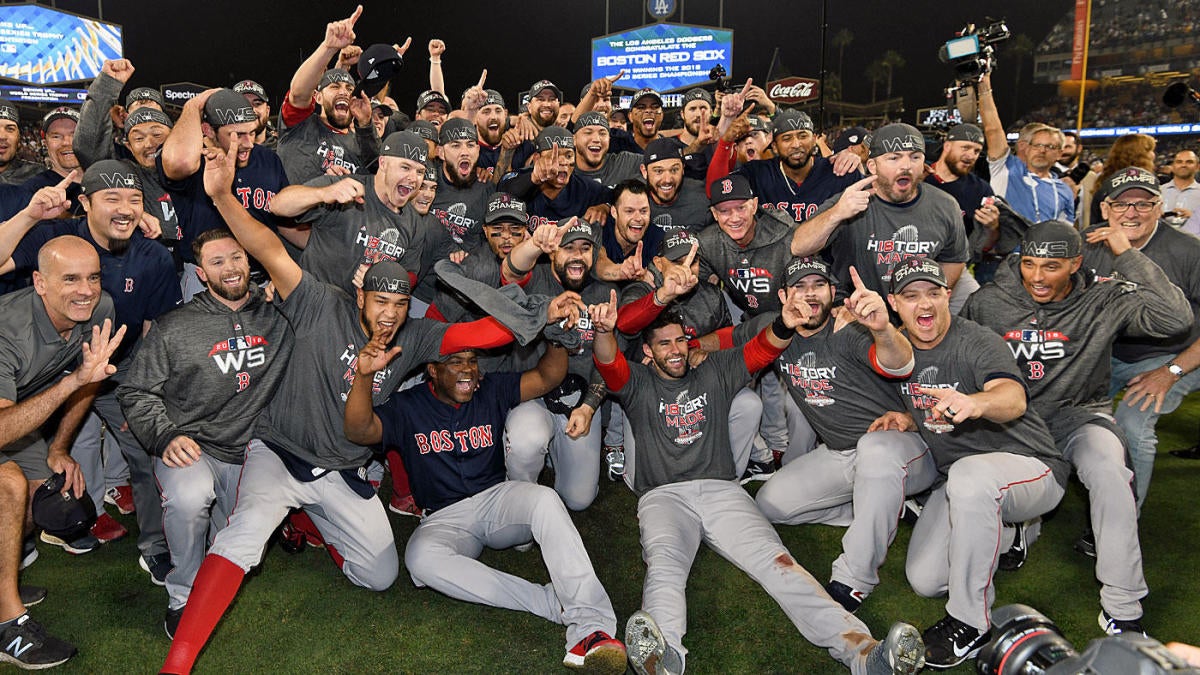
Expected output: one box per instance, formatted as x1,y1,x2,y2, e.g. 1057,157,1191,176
588,285,923,675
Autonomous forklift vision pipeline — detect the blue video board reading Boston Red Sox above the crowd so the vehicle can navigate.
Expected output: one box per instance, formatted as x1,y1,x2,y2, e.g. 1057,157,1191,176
592,23,733,92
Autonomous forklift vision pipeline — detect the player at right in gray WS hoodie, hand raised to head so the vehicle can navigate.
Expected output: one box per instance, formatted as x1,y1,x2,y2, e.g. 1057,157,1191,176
964,221,1192,634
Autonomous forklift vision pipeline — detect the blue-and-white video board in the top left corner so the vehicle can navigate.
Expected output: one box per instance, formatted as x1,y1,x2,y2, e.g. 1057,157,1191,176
0,5,124,85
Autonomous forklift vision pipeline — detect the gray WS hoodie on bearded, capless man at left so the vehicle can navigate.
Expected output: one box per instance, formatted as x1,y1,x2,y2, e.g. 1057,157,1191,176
116,286,294,464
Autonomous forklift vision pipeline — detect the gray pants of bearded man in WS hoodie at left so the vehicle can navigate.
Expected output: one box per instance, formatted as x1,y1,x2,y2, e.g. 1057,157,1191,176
154,454,241,609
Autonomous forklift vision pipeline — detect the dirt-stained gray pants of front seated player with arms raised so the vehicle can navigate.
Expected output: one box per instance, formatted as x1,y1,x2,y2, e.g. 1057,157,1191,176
637,479,876,674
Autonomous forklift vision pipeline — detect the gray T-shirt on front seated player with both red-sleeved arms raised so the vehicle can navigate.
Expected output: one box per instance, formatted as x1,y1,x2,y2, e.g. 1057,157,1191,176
613,347,750,495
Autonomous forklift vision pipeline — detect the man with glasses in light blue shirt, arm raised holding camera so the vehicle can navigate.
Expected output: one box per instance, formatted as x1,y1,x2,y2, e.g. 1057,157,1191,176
979,74,1075,222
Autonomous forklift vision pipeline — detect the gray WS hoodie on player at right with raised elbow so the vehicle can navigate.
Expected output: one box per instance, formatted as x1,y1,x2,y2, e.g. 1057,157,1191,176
962,249,1192,437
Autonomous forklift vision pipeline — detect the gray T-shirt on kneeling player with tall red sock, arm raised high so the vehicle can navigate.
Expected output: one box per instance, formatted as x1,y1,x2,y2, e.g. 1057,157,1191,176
258,273,449,470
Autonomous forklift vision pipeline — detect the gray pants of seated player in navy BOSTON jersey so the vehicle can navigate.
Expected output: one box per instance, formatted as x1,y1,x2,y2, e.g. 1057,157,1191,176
404,480,617,649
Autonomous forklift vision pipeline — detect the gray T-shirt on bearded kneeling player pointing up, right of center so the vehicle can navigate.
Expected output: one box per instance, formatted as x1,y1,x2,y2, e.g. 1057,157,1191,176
775,317,904,450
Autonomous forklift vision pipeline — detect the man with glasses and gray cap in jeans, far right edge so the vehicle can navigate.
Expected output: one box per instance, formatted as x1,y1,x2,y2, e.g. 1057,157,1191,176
1084,167,1200,508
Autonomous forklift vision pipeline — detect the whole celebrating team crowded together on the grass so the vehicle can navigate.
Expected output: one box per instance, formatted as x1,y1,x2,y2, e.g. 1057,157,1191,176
0,2,1200,675
